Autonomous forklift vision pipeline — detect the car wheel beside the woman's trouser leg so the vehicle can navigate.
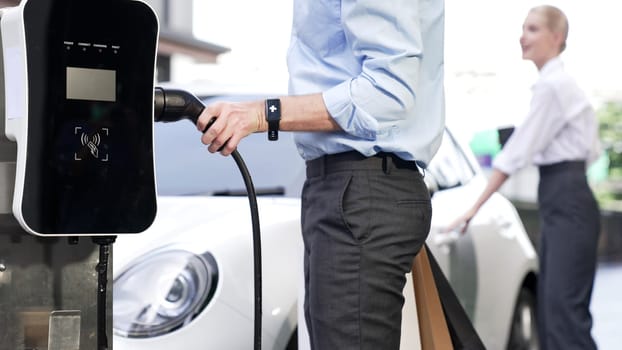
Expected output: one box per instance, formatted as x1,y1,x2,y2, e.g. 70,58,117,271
508,287,539,350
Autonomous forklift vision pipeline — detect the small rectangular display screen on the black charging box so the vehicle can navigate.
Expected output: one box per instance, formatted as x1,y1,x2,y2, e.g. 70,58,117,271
67,67,117,102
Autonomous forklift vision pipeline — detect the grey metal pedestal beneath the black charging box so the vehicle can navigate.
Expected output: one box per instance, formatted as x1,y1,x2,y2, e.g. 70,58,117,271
0,66,105,350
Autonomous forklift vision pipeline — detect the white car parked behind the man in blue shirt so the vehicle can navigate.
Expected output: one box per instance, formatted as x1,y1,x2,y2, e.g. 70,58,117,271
113,93,537,350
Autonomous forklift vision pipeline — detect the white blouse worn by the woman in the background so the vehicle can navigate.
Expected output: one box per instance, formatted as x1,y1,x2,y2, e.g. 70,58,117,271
493,57,600,175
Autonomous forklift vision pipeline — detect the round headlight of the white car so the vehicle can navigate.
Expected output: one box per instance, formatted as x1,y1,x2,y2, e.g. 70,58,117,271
113,250,218,338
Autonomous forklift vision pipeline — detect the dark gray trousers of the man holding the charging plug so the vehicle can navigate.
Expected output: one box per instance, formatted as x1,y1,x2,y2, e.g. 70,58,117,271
302,152,432,350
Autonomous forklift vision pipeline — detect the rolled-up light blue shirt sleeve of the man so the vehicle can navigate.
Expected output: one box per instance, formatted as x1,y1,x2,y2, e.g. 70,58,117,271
323,0,422,140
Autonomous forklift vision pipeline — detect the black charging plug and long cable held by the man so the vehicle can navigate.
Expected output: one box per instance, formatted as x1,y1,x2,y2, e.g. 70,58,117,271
154,87,262,350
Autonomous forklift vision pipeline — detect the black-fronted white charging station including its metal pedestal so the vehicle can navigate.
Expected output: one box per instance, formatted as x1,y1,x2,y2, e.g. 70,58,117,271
0,0,159,350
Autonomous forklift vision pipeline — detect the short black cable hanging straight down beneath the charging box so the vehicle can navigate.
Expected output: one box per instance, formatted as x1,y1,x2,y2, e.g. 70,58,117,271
92,236,117,350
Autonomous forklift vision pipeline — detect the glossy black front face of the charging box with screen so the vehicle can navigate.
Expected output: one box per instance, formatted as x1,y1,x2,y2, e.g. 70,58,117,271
22,0,158,235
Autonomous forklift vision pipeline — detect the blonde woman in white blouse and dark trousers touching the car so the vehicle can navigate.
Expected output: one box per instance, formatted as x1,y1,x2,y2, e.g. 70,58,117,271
448,6,600,350
